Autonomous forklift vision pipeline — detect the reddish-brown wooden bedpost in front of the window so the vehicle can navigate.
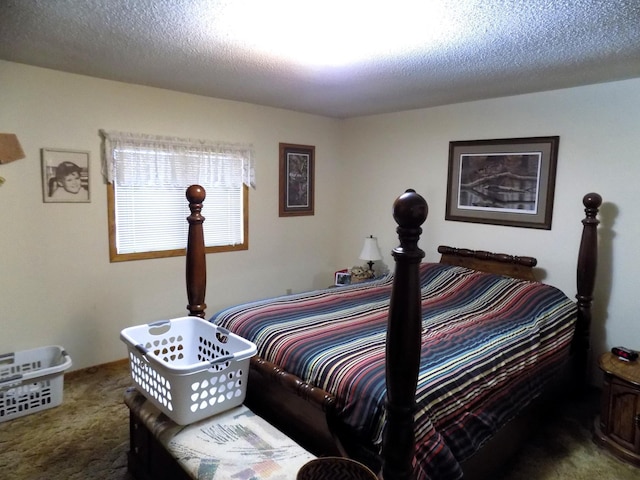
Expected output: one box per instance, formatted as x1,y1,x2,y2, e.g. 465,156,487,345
186,185,207,318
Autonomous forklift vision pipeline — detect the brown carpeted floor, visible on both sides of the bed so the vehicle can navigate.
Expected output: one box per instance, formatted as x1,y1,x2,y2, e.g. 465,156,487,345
0,362,640,480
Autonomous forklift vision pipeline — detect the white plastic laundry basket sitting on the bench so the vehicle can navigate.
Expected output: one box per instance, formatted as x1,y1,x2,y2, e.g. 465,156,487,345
120,317,256,425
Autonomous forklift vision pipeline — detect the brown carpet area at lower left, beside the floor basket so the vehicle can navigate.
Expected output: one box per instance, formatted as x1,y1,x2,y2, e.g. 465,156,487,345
0,362,133,480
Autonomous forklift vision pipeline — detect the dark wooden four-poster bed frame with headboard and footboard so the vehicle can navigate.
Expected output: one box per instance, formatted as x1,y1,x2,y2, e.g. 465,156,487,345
129,185,602,480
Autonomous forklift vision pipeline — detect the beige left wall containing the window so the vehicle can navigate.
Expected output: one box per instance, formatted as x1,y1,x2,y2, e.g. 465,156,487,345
0,61,341,369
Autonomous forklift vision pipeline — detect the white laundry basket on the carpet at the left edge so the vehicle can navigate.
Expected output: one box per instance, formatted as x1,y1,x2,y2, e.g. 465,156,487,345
0,345,71,422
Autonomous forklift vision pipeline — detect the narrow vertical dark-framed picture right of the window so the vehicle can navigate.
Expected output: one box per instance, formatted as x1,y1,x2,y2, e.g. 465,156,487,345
279,143,315,217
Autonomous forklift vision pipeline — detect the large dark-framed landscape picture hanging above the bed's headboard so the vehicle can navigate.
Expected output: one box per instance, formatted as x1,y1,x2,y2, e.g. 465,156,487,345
445,136,560,230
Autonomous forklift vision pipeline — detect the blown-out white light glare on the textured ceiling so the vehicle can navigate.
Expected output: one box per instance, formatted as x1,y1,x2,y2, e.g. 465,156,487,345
200,0,452,67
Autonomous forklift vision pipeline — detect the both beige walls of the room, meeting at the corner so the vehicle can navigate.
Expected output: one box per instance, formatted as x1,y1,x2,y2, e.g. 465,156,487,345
0,61,640,381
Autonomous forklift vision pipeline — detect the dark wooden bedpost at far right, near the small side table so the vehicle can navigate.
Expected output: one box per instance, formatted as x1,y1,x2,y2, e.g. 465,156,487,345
572,193,602,393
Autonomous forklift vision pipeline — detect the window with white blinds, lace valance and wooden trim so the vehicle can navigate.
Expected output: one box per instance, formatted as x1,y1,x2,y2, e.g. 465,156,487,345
100,131,255,262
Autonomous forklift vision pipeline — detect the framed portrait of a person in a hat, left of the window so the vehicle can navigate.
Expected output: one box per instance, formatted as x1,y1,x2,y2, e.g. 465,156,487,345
42,148,91,203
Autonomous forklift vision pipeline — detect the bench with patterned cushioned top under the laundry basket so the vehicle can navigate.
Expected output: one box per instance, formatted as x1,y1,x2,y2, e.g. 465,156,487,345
124,388,316,480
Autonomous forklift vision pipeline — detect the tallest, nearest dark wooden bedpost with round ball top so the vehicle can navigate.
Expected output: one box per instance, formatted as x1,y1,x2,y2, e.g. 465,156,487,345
382,190,429,480
